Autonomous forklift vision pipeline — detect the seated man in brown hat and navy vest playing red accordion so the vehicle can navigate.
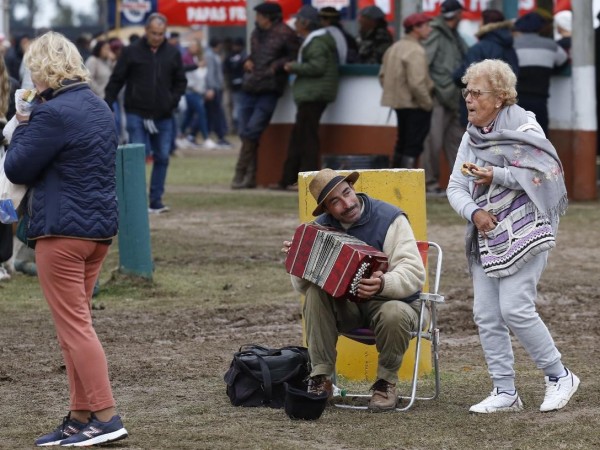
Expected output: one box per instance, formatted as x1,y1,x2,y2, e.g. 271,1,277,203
282,169,425,411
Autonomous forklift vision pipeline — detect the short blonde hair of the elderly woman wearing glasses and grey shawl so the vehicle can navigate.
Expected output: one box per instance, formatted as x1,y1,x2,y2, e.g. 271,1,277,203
461,59,517,106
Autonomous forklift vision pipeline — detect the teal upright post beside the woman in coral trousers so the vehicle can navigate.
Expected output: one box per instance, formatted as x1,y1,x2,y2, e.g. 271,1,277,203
117,144,154,279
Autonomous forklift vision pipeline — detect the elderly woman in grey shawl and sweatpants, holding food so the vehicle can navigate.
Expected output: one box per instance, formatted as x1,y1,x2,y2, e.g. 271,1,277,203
447,59,579,413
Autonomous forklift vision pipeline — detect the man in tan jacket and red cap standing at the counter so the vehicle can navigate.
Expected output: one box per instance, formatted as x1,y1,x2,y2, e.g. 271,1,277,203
379,13,433,169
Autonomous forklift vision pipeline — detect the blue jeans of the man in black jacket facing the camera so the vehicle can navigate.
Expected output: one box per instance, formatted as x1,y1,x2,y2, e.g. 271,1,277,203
126,113,175,205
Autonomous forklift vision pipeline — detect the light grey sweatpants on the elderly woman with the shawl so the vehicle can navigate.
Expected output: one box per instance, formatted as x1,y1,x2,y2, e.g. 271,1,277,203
472,252,563,391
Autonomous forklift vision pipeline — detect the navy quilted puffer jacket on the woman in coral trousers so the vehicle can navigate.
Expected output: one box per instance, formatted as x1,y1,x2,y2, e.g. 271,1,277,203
4,83,118,240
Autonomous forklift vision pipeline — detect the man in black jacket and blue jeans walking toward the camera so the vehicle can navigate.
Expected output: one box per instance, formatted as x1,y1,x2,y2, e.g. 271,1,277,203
105,13,187,214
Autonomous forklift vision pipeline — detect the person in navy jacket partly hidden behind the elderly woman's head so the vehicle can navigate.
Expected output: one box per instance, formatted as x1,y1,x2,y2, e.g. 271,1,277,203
454,9,519,127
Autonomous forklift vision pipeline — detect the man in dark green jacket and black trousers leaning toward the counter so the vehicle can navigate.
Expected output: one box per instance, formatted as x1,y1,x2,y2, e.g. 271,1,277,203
270,5,340,189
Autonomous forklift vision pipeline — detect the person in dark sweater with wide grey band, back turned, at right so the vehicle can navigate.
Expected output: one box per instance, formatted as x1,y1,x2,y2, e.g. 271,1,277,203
515,12,569,136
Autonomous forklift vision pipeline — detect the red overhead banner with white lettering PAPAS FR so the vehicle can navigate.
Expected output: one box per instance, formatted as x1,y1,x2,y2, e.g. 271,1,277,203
158,0,246,27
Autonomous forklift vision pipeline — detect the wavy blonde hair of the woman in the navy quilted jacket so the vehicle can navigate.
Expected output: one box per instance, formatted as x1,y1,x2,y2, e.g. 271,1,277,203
24,31,90,89
